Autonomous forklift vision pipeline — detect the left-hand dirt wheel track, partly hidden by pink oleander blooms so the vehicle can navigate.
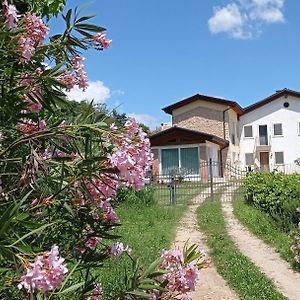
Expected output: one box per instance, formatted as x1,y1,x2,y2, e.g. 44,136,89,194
175,191,239,300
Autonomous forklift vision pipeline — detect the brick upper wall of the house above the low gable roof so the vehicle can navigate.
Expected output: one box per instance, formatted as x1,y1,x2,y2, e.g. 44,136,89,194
173,107,229,139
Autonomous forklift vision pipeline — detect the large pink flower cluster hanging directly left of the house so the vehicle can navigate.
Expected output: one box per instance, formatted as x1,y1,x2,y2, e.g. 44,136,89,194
108,118,152,190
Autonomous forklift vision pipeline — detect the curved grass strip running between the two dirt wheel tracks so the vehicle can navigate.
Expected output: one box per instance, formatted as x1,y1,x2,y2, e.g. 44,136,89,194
197,201,286,300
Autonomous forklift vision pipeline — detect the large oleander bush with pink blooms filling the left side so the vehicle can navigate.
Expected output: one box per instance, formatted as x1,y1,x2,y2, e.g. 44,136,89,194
0,0,201,300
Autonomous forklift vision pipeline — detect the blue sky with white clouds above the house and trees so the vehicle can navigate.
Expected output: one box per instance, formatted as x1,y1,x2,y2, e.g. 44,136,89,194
52,0,300,128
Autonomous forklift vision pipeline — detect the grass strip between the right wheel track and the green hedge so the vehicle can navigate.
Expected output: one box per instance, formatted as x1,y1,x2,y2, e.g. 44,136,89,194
233,193,299,269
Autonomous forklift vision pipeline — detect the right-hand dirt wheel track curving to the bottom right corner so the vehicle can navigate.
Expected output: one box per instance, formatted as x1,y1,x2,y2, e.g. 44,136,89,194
221,194,300,300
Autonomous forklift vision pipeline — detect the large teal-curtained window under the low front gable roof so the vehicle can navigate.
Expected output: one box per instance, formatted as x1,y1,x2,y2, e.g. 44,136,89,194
161,147,199,175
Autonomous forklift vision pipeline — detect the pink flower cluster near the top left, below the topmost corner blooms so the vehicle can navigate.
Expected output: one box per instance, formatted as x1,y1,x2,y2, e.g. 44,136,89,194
18,14,49,64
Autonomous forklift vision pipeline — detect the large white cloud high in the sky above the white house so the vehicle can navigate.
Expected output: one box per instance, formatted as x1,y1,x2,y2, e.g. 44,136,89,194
208,0,285,39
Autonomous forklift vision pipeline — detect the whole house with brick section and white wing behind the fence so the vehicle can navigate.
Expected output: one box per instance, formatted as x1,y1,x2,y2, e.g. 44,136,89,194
150,89,300,178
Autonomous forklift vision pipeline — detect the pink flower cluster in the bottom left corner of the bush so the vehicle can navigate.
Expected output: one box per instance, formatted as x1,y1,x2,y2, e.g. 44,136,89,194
18,246,68,293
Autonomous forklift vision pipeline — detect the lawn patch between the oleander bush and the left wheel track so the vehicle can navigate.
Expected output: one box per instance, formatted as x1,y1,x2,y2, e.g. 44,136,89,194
100,189,187,295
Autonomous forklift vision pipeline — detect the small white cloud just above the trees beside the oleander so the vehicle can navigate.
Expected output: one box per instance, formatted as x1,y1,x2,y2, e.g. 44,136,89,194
67,80,111,103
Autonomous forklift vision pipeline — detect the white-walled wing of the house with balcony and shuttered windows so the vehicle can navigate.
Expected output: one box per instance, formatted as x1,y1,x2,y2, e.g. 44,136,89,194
239,89,300,172
